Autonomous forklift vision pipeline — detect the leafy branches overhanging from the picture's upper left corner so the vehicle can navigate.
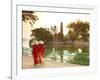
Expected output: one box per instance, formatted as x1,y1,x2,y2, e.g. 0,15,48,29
22,10,38,24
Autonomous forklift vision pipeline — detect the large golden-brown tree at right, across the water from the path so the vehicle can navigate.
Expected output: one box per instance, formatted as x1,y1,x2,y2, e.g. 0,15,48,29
67,20,89,41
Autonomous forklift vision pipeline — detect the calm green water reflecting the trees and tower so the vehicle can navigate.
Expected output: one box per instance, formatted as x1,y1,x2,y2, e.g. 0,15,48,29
23,45,89,65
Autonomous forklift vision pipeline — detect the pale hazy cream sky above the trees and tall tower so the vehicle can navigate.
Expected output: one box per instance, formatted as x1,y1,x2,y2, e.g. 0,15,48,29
33,12,90,34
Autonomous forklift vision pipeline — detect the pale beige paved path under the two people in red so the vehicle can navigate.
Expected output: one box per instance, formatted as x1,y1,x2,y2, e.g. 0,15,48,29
22,56,85,69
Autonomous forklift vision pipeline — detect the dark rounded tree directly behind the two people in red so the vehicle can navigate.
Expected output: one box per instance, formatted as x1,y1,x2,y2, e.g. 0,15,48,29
32,28,53,43
